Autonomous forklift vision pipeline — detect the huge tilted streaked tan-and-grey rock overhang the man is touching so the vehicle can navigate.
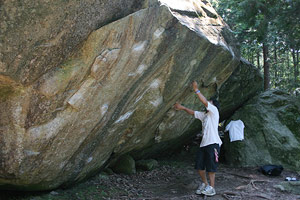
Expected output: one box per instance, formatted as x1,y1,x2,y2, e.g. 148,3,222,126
0,1,239,190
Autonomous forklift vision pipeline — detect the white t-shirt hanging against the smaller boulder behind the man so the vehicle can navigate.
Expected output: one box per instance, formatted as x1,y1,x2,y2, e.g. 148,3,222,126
225,120,245,142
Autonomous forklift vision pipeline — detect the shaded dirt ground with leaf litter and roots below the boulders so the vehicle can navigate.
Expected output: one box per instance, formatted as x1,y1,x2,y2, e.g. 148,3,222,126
0,156,300,200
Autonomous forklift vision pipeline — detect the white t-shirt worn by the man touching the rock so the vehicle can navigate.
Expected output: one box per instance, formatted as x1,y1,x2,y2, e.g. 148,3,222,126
194,102,222,147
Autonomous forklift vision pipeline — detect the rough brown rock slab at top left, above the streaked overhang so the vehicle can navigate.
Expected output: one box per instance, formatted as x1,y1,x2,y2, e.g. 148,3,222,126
0,0,146,85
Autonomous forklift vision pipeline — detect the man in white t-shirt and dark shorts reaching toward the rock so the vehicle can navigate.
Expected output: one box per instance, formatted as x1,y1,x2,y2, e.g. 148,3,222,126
174,81,222,196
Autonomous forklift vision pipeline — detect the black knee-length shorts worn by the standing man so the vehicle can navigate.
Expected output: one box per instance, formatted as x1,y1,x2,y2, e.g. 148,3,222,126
195,144,220,172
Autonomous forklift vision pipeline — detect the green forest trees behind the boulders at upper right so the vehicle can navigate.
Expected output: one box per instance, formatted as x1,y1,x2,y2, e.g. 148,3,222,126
212,0,300,96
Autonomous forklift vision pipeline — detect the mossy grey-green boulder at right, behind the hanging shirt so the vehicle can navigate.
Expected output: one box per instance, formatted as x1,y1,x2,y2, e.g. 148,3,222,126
224,90,300,170
